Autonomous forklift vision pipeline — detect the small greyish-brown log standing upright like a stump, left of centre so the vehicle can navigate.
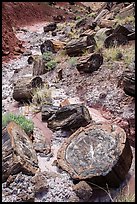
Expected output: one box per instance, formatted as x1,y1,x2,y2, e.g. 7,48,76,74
33,56,47,76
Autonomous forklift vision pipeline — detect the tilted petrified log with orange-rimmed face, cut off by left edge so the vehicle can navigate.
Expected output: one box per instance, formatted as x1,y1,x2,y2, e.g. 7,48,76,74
2,122,38,182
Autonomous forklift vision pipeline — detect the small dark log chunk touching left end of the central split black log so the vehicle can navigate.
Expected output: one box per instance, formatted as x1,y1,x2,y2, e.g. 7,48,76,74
41,105,59,121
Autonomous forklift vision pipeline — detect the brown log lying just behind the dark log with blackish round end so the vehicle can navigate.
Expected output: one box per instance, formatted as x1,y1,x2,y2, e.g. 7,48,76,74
64,35,96,57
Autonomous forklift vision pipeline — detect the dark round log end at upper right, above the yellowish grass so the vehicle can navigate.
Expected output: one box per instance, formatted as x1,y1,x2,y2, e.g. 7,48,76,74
104,33,128,48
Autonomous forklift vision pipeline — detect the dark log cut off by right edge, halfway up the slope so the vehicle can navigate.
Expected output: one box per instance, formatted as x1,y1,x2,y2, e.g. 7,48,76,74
123,70,135,97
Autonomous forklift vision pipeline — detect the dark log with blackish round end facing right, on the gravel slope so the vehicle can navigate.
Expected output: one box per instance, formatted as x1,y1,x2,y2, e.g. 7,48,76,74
76,53,103,73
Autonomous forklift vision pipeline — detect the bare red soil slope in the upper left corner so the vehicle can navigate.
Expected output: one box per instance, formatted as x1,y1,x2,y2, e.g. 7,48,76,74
2,2,85,61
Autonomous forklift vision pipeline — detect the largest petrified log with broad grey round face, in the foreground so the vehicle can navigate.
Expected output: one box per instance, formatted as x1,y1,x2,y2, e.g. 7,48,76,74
57,124,133,187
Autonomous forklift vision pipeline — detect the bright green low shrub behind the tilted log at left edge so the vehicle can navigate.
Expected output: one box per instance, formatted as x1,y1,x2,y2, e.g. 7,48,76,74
2,113,34,135
